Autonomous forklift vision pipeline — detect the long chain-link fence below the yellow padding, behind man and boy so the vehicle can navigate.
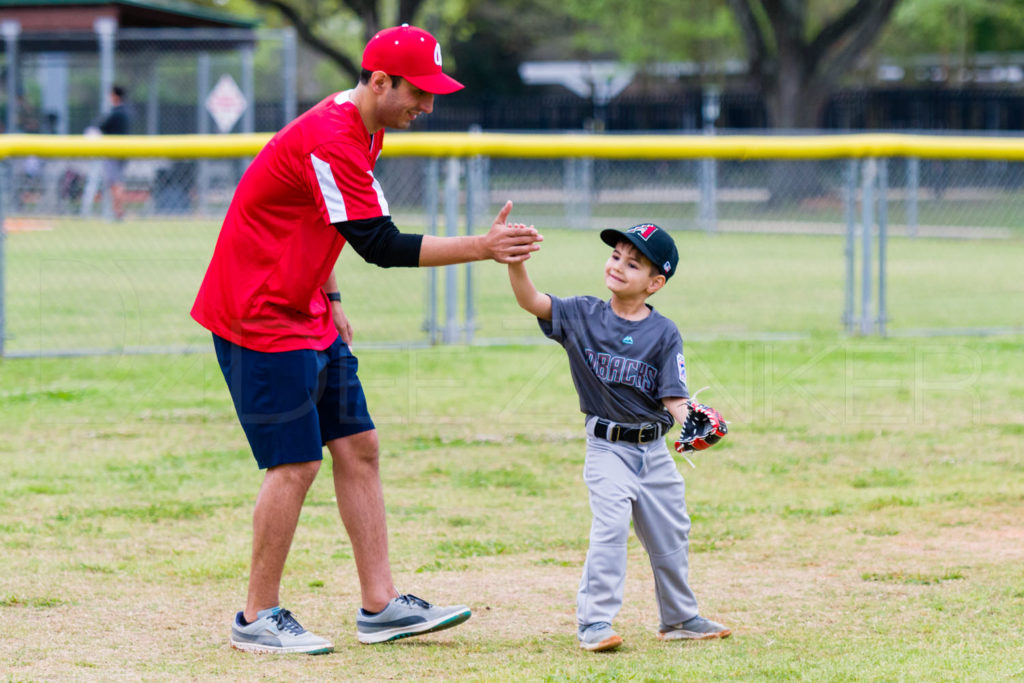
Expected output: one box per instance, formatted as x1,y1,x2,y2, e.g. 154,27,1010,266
0,136,1024,355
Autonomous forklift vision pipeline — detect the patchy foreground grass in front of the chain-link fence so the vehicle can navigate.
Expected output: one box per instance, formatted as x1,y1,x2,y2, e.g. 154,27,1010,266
0,337,1024,681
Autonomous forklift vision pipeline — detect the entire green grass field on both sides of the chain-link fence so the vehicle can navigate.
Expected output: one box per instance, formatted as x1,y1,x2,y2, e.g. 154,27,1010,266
0,216,1024,681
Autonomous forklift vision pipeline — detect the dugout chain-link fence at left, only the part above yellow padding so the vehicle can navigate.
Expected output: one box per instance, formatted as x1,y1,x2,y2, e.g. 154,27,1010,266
0,29,297,135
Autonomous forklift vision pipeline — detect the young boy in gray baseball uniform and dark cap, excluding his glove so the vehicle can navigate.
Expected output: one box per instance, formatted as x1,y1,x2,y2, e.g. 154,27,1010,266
509,223,731,651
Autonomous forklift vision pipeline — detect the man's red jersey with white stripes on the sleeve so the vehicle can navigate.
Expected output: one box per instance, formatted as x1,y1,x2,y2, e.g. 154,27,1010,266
191,91,390,351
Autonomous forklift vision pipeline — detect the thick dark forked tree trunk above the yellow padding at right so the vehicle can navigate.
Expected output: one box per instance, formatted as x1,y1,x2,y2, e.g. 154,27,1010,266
726,0,900,128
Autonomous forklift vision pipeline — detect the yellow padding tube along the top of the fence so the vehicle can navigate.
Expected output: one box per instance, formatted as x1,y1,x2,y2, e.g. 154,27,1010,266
0,133,1024,161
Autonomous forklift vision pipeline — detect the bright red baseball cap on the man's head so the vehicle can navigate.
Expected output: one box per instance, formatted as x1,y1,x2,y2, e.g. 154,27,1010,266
362,24,464,95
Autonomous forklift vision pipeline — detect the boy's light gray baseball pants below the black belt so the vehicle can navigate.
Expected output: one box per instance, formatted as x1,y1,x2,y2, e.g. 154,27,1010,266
577,418,697,631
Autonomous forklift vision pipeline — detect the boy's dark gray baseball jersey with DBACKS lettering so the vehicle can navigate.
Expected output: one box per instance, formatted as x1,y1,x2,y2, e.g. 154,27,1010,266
539,295,690,429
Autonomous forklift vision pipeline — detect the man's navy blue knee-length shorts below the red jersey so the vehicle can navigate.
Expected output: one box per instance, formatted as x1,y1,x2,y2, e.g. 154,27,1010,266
213,335,374,469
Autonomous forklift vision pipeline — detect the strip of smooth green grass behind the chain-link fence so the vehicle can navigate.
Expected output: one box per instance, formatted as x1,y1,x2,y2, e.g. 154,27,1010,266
5,216,1024,354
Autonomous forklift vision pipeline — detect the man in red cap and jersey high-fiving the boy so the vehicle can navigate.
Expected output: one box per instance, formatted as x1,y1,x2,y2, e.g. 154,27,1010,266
191,25,542,654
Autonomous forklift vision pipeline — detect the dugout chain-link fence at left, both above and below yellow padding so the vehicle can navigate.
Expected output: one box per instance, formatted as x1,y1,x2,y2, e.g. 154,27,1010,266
0,28,297,218
